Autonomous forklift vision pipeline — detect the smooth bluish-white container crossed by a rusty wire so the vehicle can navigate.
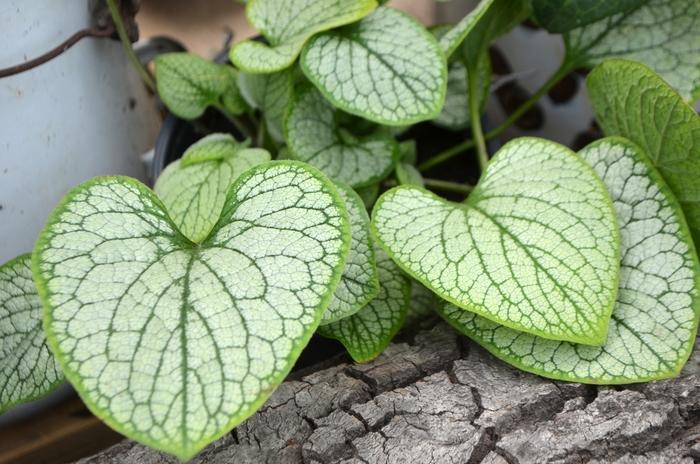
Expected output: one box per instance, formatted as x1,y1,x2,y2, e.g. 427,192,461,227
0,0,159,263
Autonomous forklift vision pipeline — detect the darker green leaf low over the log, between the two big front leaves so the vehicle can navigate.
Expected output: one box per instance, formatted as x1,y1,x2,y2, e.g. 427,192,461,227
318,249,411,363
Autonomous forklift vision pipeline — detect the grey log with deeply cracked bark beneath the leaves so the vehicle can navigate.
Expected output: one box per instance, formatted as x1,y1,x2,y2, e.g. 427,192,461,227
79,324,700,464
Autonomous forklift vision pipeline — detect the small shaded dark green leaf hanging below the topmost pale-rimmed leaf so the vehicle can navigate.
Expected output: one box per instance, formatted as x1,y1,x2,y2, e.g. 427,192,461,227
238,70,294,142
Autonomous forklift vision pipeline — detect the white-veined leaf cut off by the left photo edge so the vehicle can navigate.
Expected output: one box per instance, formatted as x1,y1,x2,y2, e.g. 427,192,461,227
0,255,63,413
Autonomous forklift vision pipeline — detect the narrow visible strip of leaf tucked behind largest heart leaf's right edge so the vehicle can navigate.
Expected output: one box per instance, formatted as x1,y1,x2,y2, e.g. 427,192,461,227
321,185,379,324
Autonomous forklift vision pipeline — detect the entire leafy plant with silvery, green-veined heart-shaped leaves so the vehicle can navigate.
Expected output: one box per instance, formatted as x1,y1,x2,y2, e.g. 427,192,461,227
0,0,700,460
